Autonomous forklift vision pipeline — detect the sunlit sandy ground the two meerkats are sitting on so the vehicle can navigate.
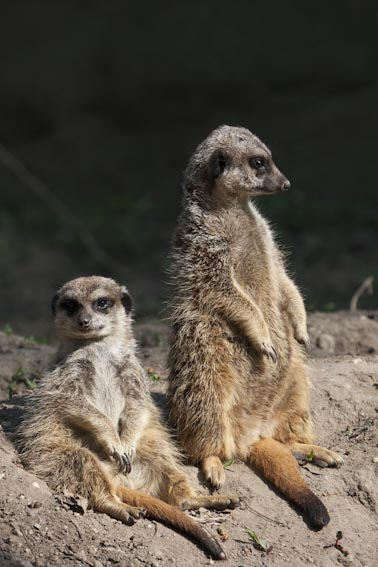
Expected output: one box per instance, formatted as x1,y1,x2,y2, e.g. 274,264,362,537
0,312,378,567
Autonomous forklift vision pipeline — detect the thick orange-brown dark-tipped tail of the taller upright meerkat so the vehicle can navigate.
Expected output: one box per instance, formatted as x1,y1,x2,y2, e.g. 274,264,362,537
248,438,330,529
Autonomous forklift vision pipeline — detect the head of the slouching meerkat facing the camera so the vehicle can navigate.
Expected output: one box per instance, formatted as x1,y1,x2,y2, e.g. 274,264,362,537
52,276,132,340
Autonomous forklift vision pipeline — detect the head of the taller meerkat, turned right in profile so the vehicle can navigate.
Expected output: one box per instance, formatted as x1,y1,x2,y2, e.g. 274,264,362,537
184,126,290,209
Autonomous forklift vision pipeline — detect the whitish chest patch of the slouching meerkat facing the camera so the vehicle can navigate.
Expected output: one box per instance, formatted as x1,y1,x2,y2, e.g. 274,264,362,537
91,366,125,426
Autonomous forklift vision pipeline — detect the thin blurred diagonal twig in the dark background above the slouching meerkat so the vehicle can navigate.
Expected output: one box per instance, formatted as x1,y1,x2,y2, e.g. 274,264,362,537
0,144,123,271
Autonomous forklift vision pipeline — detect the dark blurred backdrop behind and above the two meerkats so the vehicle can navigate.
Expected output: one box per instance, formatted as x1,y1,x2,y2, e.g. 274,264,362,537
0,0,378,338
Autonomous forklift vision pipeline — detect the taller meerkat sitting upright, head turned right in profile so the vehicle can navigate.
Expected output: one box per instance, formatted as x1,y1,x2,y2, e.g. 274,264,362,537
168,126,342,527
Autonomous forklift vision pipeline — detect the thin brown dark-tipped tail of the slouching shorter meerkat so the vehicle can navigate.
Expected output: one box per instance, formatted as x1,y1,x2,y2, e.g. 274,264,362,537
117,486,226,559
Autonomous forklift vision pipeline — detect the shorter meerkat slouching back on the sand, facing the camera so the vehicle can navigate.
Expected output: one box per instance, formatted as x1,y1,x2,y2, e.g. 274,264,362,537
19,276,238,559
